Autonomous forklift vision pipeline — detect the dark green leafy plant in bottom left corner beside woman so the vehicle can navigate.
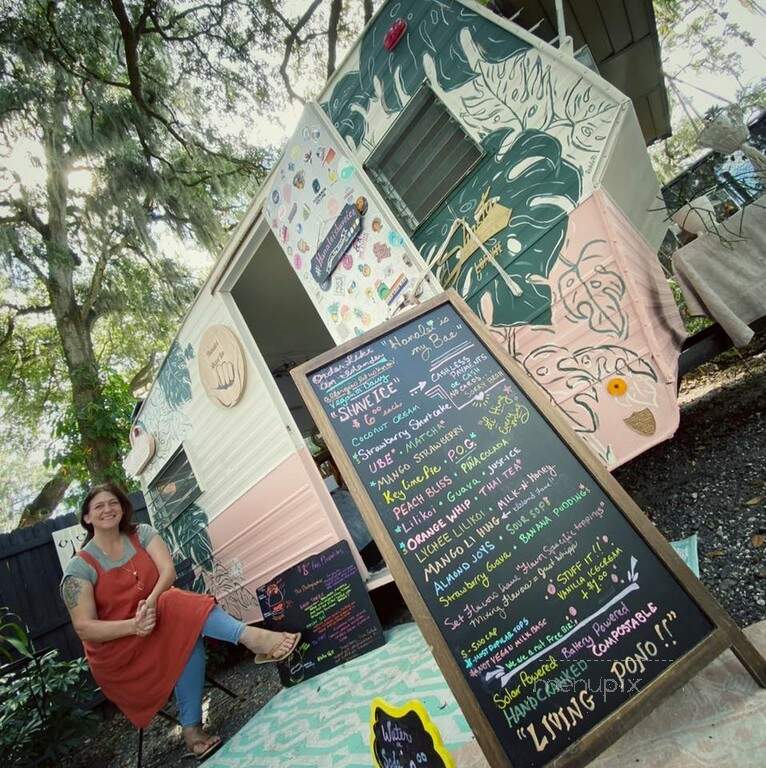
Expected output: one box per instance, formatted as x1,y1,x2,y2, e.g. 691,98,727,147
0,608,96,768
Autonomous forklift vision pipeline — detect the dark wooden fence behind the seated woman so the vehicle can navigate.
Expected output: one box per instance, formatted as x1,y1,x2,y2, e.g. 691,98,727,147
0,493,149,659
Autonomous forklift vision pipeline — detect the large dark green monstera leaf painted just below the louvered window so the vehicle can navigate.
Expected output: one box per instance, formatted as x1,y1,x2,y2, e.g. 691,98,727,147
413,130,580,326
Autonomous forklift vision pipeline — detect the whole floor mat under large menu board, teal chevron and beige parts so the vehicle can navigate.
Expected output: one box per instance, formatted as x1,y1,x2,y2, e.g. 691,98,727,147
205,621,766,768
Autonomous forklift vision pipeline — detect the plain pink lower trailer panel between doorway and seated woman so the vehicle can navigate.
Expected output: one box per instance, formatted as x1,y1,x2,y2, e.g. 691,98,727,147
206,449,366,622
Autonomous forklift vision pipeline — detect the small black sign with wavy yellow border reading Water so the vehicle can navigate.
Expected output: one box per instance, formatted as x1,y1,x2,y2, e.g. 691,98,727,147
370,699,455,768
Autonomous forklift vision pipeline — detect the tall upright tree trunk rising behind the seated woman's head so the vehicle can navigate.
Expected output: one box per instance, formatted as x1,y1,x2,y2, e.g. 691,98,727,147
40,70,121,483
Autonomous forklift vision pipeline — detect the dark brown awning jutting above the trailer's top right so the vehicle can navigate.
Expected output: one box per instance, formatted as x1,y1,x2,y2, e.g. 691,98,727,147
494,0,672,144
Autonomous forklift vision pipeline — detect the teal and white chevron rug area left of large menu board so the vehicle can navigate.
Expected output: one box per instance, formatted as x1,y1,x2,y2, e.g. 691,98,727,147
205,624,471,768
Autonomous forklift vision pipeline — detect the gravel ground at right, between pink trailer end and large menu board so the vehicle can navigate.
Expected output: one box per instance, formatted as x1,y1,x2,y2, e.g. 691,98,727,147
614,338,766,627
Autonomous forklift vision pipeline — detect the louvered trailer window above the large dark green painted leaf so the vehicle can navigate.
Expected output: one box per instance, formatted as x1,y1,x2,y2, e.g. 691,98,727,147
365,85,482,233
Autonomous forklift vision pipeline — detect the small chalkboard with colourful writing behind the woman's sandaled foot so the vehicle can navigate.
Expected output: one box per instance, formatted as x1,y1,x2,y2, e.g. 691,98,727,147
256,540,386,686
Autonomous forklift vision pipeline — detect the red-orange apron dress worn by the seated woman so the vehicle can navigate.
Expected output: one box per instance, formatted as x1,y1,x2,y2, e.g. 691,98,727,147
78,533,215,728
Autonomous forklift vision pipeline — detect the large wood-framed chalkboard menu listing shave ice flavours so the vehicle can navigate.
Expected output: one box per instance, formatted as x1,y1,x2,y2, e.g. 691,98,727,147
293,292,766,768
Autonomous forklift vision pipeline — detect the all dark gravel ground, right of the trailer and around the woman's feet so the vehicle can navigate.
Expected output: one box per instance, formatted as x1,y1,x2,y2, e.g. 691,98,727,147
68,338,766,768
